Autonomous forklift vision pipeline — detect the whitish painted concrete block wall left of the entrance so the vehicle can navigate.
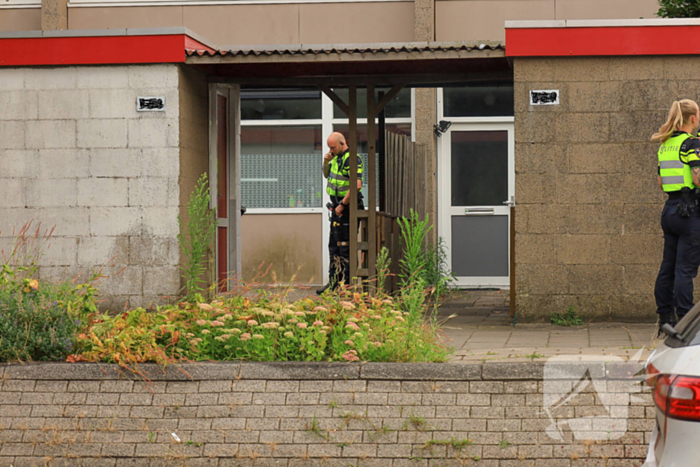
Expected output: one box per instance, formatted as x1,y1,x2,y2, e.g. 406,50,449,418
0,65,186,309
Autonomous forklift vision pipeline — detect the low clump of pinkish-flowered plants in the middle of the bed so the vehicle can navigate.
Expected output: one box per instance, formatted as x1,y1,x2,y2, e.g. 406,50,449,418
78,290,449,366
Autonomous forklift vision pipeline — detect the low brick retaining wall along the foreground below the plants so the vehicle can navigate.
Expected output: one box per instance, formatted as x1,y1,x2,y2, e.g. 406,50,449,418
0,363,654,467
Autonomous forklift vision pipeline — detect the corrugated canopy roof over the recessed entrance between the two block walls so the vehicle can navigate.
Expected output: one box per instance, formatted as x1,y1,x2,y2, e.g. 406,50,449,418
186,41,512,86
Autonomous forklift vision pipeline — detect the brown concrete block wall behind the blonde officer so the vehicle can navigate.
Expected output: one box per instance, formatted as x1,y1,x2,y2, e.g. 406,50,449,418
514,57,700,320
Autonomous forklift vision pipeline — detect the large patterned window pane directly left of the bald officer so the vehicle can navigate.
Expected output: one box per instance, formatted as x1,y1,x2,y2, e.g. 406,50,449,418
241,125,325,208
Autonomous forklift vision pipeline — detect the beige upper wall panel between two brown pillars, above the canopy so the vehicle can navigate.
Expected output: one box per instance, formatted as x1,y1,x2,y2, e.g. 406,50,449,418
69,2,413,46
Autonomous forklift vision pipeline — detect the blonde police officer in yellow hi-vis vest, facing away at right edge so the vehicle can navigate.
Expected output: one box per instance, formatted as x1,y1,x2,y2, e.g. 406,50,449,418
651,99,700,336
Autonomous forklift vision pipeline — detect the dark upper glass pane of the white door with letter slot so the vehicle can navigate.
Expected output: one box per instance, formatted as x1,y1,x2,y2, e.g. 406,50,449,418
450,131,508,206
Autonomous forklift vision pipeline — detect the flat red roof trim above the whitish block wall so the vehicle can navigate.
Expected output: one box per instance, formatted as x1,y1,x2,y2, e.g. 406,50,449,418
0,34,187,66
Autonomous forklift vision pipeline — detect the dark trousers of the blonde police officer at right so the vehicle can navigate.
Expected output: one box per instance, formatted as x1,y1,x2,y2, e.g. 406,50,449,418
654,199,700,319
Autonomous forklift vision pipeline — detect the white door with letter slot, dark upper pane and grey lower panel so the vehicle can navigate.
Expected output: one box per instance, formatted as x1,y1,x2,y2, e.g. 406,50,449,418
438,122,515,288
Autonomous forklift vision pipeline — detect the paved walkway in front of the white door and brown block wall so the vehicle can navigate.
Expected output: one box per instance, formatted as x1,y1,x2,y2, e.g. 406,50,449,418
438,290,661,363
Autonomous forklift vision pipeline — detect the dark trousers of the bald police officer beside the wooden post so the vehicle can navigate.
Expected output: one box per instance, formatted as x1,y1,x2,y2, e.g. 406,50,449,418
328,193,365,289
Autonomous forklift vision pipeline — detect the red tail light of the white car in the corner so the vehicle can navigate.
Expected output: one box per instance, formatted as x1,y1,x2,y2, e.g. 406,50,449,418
647,369,700,421
